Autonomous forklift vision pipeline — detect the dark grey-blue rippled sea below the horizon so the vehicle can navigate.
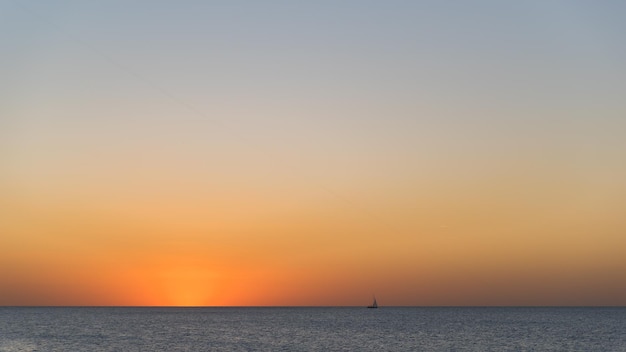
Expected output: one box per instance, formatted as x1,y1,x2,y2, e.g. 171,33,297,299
0,307,626,352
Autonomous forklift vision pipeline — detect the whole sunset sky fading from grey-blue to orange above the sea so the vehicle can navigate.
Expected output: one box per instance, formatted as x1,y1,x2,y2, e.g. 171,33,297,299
0,0,626,306
